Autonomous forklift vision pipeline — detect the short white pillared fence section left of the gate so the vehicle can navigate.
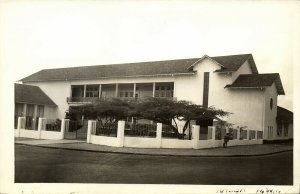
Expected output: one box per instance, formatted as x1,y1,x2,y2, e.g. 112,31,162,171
15,117,68,139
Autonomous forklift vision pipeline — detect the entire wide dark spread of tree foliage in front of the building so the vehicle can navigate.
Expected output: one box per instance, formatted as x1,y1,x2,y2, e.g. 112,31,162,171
77,97,229,139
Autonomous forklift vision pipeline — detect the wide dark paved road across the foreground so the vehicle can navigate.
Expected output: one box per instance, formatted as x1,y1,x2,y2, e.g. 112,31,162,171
15,145,293,185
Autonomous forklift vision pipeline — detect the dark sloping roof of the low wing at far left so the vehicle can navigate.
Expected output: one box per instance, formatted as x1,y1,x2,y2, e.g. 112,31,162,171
15,84,57,106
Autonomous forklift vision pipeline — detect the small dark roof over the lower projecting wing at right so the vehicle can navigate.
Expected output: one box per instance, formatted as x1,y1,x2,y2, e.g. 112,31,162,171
225,73,284,95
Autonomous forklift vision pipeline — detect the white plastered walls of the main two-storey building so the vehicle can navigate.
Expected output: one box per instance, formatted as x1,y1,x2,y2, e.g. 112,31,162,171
25,58,277,136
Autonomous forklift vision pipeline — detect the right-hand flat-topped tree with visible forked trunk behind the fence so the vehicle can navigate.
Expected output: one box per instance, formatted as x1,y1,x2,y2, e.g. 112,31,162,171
135,98,229,138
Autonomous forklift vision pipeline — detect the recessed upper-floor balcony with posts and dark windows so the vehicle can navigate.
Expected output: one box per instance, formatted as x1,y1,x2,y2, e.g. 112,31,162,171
67,82,176,104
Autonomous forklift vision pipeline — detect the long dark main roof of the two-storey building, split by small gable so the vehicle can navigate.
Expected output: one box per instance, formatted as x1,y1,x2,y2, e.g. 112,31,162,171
20,54,256,83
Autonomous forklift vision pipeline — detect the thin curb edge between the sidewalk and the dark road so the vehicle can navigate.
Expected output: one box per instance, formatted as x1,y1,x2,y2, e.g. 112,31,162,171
15,143,293,158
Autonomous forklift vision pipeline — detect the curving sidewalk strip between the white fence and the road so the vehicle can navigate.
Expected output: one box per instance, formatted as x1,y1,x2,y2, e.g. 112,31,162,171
15,138,293,157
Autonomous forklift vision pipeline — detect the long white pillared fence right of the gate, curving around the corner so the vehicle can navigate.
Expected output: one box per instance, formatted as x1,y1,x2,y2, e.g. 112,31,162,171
87,120,262,149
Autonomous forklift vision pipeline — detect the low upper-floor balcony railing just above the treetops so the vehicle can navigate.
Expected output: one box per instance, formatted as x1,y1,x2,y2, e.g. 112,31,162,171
67,97,177,103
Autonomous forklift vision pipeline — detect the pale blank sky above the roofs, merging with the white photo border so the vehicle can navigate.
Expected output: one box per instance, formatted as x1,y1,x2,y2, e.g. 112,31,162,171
0,1,299,110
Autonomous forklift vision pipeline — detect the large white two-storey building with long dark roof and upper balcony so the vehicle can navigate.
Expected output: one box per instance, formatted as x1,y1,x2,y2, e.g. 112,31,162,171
20,54,290,139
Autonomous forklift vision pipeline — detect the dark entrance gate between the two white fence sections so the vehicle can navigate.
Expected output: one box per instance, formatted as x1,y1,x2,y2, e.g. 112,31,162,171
64,120,88,140
